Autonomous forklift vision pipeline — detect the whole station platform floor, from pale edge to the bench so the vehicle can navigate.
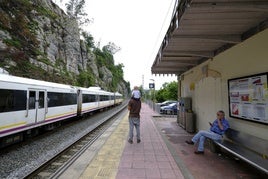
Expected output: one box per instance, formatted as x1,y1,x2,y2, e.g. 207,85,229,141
59,103,262,179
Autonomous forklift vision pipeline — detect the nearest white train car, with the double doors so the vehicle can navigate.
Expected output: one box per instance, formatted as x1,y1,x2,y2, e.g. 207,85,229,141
0,74,77,138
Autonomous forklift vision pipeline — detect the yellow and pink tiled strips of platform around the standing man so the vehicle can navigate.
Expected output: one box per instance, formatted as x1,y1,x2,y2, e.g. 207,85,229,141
80,105,182,179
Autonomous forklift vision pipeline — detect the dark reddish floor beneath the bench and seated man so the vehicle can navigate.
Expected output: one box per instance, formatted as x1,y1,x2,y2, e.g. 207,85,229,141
153,114,268,179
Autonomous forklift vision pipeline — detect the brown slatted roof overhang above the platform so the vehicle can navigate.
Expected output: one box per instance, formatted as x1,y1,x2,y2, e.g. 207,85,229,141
151,0,268,75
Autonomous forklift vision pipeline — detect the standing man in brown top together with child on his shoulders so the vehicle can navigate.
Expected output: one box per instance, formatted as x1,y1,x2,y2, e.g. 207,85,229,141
128,86,141,144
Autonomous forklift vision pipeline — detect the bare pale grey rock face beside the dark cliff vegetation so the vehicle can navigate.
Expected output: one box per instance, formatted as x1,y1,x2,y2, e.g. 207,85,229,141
31,0,88,75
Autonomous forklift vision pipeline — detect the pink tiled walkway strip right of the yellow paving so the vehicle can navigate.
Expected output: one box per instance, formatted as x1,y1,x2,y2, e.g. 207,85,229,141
116,104,183,179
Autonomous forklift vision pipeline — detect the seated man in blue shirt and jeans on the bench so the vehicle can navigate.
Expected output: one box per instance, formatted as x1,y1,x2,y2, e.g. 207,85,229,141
185,111,229,154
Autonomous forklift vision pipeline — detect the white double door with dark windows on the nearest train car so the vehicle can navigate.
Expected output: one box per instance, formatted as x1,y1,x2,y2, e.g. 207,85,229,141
28,89,46,122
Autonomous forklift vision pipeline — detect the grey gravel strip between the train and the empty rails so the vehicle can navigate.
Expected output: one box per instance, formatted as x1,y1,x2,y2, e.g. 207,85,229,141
0,105,123,179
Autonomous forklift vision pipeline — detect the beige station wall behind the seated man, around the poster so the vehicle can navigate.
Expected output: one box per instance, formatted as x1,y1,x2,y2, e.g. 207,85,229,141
181,29,268,140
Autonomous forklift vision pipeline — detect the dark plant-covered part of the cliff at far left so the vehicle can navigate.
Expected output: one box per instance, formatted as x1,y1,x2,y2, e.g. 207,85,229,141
0,0,56,78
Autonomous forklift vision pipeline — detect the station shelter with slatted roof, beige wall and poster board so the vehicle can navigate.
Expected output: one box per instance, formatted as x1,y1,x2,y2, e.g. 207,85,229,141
151,0,268,140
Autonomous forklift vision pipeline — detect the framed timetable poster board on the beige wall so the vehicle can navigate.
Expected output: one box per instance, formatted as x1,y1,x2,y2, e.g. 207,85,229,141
228,73,268,124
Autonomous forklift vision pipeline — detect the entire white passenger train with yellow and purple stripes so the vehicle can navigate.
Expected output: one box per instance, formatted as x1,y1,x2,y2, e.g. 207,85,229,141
0,74,123,147
